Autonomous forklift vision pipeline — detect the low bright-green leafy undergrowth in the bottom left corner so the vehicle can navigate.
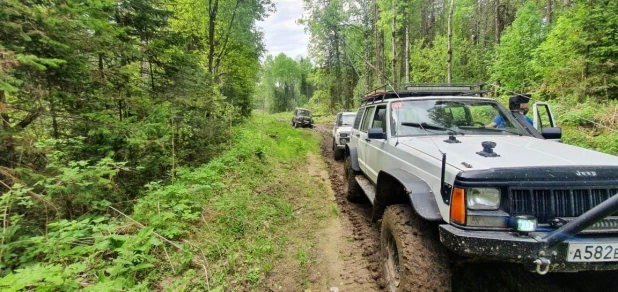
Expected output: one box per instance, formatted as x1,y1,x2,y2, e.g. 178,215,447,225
0,213,162,291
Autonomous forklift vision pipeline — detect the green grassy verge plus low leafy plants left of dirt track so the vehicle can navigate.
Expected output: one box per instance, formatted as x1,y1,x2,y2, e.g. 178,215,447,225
0,112,332,291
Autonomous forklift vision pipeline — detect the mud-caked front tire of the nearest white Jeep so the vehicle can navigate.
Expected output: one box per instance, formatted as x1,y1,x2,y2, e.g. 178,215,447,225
380,205,452,292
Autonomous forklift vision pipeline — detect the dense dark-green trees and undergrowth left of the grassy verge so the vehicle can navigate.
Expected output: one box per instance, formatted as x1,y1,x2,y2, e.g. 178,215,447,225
0,0,274,291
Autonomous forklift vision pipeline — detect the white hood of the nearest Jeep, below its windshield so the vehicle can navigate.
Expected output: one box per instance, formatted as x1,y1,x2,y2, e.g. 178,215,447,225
399,135,618,171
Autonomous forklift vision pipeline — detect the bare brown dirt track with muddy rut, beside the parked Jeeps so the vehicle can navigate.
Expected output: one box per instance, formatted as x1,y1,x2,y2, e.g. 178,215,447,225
264,126,383,292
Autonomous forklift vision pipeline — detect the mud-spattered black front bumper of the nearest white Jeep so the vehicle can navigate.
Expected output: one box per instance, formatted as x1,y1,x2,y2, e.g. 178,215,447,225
440,224,618,272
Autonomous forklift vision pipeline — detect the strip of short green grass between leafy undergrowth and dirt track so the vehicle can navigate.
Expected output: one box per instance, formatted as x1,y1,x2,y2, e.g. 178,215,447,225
150,112,332,291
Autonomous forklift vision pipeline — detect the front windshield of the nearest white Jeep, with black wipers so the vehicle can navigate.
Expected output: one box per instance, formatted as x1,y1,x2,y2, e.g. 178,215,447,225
391,99,529,137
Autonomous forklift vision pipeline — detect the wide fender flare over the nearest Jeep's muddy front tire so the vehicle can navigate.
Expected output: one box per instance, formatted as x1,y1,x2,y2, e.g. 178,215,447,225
372,168,443,222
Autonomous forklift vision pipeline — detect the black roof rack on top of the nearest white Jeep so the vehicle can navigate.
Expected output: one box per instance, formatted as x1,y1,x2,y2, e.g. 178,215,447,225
361,83,489,104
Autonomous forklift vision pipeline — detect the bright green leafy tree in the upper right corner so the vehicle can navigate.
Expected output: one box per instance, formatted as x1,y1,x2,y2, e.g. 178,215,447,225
535,1,618,101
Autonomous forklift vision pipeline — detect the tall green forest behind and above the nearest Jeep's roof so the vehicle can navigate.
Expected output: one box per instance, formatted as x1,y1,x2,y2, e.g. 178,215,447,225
304,0,618,107
